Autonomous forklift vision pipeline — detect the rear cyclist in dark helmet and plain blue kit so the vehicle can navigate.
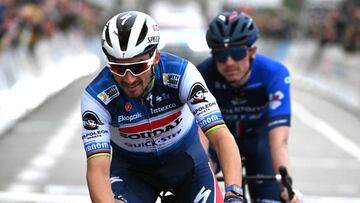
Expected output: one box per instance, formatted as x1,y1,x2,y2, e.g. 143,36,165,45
197,12,300,202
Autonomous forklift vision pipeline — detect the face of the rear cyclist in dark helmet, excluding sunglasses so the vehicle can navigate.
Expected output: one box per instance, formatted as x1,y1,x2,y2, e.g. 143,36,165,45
215,46,256,86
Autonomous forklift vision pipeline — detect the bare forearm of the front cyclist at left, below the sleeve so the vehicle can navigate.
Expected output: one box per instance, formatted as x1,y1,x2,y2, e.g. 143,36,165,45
86,156,115,203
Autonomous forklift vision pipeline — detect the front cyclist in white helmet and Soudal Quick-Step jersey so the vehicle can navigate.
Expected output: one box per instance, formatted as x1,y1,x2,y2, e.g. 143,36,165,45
81,11,243,203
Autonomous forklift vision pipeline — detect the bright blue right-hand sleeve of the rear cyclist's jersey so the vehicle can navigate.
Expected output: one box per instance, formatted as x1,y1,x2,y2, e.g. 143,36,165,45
267,66,291,128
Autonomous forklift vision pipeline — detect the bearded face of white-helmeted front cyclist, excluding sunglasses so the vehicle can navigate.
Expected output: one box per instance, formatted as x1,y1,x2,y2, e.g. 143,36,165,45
113,54,156,97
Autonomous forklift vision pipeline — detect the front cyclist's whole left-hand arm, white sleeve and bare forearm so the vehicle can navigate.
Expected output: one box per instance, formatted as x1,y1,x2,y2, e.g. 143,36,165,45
81,91,115,203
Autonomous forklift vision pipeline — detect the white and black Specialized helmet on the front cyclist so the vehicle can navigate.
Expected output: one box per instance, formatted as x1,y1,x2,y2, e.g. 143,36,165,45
101,11,160,60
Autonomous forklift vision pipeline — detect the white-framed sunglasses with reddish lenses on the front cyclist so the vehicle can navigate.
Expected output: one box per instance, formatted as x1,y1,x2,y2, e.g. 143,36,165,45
108,51,156,77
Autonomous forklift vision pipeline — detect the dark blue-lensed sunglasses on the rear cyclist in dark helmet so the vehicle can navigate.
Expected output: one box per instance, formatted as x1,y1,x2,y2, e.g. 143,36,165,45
211,46,249,63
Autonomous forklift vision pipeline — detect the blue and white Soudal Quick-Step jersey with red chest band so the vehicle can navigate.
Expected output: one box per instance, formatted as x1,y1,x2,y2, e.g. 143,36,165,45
81,52,225,164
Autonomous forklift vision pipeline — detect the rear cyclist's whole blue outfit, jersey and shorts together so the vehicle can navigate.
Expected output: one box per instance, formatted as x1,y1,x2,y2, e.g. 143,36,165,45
198,54,291,202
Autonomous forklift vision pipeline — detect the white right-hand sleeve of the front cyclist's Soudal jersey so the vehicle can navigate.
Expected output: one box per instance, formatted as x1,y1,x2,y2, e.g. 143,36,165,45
179,63,225,135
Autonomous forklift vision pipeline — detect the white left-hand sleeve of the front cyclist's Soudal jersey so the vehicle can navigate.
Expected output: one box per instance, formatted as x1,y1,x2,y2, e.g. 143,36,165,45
81,91,111,159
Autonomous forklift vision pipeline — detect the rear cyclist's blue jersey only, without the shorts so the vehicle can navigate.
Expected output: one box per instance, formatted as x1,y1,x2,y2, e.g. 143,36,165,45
198,54,291,136
